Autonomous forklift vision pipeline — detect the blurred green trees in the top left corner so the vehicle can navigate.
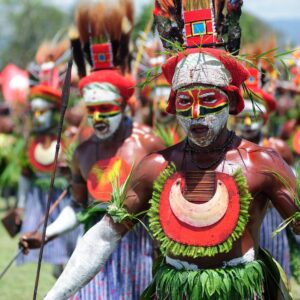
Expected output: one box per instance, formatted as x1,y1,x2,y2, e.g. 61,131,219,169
0,0,71,68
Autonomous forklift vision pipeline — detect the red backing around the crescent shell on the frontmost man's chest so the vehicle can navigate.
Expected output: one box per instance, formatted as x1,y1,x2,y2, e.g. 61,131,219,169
159,173,240,247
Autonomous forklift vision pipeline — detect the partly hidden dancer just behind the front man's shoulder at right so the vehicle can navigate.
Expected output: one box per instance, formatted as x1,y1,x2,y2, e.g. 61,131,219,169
234,68,293,278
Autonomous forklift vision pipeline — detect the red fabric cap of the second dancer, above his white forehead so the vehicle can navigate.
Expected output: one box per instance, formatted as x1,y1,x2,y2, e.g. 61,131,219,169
79,70,135,102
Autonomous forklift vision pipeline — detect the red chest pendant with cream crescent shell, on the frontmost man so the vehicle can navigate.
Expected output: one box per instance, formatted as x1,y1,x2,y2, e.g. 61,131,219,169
159,171,240,247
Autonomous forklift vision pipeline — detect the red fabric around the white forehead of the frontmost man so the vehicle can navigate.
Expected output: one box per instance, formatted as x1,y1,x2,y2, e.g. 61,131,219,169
162,48,250,115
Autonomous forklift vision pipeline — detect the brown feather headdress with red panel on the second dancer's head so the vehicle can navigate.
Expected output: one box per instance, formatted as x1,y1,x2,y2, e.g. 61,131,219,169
73,0,134,74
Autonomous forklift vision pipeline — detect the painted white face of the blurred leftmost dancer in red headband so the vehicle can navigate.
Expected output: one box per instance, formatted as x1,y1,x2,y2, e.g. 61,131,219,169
31,98,53,132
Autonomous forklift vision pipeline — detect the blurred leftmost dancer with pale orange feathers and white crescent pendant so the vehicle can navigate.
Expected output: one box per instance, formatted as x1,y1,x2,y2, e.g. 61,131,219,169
17,32,80,270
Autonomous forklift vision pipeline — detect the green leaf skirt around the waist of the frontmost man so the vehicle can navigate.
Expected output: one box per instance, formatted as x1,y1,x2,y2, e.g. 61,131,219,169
141,261,263,300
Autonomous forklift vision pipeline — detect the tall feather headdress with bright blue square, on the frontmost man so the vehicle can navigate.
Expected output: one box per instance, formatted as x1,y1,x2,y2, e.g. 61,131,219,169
154,0,243,53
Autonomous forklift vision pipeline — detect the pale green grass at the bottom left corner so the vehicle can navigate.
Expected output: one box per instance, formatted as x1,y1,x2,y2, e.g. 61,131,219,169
0,199,55,300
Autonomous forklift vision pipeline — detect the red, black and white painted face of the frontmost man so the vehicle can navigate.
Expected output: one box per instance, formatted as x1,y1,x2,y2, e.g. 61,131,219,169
176,87,229,147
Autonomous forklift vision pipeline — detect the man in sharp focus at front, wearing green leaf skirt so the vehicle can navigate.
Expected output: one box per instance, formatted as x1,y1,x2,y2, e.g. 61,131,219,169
45,0,300,300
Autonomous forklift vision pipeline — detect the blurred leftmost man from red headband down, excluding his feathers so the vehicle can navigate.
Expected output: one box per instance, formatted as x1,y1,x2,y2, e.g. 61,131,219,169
17,85,78,272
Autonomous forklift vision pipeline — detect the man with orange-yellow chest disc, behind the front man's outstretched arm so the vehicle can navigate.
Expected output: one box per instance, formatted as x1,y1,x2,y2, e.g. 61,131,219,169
22,0,163,300
